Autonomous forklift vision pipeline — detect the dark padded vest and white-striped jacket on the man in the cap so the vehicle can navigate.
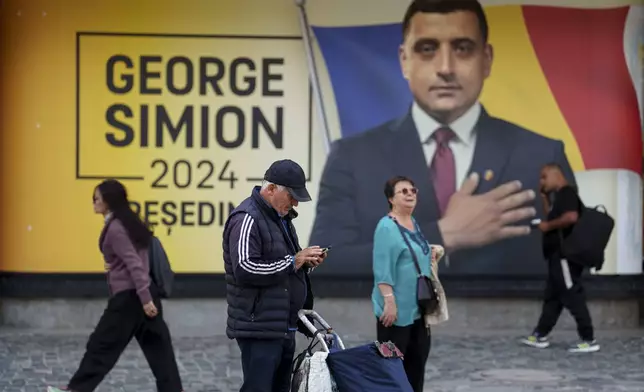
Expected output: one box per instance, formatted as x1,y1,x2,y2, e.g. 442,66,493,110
223,187,313,339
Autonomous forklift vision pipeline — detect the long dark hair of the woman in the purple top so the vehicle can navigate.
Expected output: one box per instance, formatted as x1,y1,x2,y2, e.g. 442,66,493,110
94,180,152,249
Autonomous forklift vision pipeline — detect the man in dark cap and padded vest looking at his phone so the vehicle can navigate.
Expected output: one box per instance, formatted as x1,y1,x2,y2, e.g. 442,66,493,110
223,160,326,392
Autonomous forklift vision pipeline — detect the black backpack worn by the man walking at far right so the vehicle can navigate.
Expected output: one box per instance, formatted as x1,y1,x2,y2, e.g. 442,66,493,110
559,200,615,271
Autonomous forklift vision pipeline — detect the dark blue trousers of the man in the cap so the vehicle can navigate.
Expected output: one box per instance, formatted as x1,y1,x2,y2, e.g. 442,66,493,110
237,332,295,392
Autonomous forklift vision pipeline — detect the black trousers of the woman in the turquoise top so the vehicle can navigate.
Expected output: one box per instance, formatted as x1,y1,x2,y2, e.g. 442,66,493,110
377,317,432,392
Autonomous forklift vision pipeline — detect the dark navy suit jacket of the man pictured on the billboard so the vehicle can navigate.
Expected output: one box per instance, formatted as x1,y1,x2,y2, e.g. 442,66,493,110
310,110,574,276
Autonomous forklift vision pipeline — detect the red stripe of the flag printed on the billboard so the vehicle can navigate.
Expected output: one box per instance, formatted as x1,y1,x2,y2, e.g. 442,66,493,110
523,6,642,173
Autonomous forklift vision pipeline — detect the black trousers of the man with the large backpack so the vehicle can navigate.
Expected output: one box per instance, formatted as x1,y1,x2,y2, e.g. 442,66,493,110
535,254,595,341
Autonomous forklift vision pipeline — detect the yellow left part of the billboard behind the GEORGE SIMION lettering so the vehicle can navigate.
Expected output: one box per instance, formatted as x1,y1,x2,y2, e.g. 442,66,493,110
0,0,324,272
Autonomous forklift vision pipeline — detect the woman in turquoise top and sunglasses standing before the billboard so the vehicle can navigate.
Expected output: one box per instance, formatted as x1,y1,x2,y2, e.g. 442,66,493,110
371,177,431,392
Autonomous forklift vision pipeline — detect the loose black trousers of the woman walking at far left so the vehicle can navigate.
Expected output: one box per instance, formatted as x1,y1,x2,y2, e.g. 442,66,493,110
68,287,183,392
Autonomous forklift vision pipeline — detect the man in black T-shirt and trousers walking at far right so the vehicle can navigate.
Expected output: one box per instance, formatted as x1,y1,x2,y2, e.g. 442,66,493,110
522,164,599,352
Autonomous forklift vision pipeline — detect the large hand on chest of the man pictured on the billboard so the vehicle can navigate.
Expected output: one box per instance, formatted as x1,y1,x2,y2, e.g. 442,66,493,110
438,173,536,250
